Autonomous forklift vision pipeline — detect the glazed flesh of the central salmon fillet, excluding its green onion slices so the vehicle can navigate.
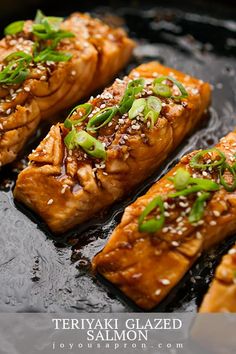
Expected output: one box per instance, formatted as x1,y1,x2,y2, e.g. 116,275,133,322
14,62,210,233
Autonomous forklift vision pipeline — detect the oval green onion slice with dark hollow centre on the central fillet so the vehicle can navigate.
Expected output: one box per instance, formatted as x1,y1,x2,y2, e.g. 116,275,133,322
87,107,118,131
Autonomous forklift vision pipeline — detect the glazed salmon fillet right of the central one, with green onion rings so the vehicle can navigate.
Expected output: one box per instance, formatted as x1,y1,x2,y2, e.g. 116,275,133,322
93,132,236,310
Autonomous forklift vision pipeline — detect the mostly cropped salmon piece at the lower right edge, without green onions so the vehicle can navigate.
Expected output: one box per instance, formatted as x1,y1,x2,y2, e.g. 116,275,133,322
199,245,236,312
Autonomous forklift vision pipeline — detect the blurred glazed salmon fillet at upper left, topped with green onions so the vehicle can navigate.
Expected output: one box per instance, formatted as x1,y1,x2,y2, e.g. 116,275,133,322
0,13,135,166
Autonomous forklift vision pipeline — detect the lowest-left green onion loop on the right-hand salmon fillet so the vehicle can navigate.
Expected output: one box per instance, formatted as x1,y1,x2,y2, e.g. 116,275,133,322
138,196,165,233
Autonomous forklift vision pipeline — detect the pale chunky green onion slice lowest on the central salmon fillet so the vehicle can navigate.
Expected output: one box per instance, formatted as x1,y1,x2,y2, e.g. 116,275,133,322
64,128,106,160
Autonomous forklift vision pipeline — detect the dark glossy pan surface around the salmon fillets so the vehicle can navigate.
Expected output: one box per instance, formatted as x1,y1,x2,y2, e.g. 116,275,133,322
0,3,236,312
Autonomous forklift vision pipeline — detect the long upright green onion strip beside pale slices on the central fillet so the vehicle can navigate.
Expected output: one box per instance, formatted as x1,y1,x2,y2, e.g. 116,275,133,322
118,78,144,114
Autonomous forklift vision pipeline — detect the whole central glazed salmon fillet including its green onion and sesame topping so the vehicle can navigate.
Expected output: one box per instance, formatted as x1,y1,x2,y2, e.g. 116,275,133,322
14,62,211,233
